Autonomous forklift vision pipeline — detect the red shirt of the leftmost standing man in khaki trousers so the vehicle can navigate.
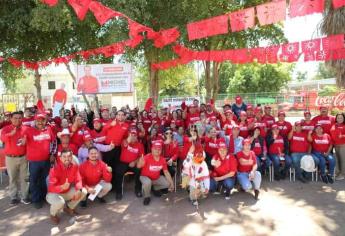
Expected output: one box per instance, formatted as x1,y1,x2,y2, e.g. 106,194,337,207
1,124,26,156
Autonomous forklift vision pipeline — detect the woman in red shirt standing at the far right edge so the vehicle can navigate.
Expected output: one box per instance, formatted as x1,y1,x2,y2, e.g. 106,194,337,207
331,113,345,180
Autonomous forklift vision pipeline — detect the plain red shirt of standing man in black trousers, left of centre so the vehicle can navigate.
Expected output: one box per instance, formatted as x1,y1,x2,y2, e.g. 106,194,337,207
104,122,129,146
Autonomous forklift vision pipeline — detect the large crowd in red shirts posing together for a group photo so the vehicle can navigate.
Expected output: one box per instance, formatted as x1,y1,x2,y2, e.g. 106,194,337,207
0,96,345,223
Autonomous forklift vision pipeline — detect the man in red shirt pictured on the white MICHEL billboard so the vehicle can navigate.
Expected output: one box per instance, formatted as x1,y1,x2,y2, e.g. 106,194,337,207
77,66,99,94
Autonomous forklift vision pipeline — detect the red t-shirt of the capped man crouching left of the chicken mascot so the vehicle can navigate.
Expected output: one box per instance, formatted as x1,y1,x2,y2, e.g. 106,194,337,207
141,153,168,180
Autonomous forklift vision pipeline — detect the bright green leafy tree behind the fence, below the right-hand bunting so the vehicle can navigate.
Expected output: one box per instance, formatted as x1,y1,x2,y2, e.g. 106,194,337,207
227,63,292,93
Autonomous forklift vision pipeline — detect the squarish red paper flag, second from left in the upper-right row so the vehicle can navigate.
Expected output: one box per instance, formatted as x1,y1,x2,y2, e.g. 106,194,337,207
229,7,255,32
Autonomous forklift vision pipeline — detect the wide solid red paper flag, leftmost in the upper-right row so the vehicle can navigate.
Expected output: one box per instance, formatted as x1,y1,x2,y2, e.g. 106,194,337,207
187,15,229,41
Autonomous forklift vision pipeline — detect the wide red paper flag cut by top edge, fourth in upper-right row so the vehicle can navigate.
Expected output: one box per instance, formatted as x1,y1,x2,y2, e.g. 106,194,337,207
290,0,325,17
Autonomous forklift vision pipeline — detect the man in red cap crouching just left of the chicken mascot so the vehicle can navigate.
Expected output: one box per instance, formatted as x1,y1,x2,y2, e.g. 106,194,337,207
137,142,174,205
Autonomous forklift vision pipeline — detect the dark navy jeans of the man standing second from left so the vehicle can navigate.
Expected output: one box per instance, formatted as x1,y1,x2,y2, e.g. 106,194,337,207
29,161,50,203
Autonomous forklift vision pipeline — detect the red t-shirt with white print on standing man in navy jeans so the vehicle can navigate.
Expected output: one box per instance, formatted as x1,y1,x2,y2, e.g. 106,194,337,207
25,127,55,161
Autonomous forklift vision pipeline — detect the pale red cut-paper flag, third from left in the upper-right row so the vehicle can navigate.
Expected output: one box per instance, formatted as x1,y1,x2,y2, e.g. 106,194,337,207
256,0,286,25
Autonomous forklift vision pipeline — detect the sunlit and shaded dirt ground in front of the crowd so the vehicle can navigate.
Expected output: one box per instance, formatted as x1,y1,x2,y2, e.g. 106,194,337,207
0,173,345,236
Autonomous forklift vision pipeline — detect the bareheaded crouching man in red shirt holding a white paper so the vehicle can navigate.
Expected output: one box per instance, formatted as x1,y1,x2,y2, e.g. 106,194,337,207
79,147,112,207
